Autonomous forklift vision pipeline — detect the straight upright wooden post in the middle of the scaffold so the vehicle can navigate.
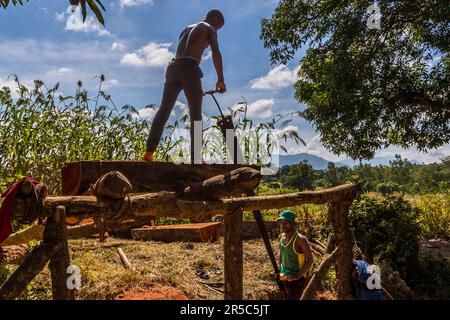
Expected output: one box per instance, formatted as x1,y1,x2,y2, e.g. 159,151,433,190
224,208,244,300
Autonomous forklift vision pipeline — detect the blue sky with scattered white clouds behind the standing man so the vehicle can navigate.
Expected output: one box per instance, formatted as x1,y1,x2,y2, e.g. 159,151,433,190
0,0,450,163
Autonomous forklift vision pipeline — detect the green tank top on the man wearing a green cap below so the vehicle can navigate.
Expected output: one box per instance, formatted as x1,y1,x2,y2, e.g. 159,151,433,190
279,232,305,275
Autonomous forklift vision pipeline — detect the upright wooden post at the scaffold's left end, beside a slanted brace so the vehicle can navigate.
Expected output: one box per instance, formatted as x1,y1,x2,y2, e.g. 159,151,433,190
44,206,75,300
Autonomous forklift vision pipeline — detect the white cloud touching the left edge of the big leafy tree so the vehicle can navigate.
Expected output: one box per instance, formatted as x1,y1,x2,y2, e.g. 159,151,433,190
250,65,299,90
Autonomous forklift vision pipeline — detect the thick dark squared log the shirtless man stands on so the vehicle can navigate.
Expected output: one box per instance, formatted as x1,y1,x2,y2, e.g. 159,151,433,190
61,161,260,195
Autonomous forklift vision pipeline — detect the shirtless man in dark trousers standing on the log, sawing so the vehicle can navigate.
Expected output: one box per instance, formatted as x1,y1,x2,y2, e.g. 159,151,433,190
143,10,226,163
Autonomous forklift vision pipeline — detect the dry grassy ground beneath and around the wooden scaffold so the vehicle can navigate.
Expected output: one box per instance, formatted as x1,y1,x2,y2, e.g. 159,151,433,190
11,237,334,300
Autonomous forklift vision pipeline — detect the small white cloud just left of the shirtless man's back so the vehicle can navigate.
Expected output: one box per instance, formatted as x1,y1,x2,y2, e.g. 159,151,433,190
120,42,175,67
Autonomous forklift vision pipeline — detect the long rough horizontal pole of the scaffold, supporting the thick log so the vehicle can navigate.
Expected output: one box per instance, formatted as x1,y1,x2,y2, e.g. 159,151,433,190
9,184,360,219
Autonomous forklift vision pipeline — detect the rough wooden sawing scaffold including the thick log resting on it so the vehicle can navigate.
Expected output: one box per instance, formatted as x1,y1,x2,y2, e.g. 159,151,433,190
0,161,360,300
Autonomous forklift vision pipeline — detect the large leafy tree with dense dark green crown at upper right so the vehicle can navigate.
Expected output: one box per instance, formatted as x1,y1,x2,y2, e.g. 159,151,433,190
261,0,450,159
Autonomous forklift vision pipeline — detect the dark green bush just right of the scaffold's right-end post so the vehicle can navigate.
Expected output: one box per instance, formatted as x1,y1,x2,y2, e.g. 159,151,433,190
349,196,420,279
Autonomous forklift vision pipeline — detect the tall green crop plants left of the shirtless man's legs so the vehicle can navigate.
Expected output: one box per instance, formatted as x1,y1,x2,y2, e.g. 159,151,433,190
0,77,148,194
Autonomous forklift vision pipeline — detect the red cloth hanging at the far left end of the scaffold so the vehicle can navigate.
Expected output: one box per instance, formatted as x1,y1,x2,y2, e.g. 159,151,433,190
0,177,40,243
